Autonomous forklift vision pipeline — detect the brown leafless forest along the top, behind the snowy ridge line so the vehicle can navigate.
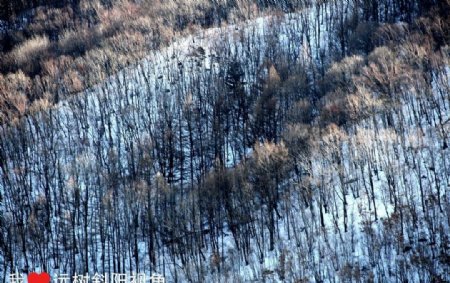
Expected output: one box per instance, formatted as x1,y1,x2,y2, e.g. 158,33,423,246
0,0,447,123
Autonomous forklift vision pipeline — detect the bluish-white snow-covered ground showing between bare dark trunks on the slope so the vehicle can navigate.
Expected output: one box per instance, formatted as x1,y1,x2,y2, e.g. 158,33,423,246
0,2,450,282
